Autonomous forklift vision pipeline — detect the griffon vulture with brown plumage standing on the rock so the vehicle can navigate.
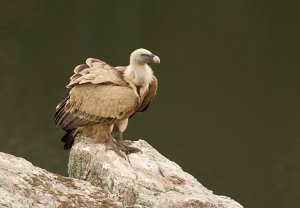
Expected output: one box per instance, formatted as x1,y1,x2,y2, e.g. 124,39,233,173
54,49,160,156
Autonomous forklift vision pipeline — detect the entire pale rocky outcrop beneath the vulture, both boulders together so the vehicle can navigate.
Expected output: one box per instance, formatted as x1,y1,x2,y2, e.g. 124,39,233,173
0,138,242,208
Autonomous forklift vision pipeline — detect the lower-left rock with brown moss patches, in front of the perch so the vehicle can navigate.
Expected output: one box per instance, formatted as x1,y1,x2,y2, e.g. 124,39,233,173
0,153,122,208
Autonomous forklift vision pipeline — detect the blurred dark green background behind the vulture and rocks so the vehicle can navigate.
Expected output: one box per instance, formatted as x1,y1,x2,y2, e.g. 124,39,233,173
0,0,300,208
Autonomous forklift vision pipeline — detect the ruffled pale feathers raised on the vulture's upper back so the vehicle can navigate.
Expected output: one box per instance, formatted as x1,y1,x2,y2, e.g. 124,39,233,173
67,58,128,88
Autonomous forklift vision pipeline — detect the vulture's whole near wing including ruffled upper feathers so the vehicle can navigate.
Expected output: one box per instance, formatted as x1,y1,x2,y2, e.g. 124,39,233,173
54,59,138,131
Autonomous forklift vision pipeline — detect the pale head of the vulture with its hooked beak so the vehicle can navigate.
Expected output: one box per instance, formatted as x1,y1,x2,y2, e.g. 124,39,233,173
130,48,160,65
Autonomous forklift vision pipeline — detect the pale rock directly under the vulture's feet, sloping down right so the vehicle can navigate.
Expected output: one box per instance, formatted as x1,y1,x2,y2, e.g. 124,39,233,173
68,138,242,208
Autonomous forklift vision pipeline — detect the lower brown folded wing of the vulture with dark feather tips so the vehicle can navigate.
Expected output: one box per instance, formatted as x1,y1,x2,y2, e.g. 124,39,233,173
55,84,138,130
